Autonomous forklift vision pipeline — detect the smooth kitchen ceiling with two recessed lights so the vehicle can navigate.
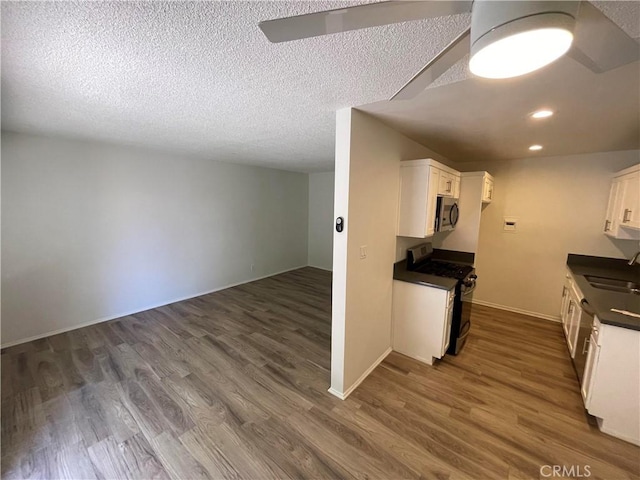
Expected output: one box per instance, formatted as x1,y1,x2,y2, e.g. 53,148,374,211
360,58,640,162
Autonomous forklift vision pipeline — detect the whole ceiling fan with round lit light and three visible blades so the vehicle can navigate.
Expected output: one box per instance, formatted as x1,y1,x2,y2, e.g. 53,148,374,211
259,0,640,100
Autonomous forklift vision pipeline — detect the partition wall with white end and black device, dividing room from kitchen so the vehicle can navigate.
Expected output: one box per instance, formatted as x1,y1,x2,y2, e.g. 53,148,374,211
331,109,436,397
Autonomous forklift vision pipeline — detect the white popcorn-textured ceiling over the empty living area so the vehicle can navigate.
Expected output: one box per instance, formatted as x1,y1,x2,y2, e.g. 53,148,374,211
1,1,640,171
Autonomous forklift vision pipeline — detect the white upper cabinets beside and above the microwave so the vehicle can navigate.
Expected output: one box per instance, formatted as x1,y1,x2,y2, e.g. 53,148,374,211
397,159,460,238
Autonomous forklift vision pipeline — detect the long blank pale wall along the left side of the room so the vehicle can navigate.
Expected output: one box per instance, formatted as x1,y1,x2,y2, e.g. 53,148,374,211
2,133,308,345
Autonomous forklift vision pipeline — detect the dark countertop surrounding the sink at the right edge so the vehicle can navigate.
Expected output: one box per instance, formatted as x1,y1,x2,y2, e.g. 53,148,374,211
567,253,640,330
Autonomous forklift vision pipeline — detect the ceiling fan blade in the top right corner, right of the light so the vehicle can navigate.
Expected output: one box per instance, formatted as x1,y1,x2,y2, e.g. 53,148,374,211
567,1,640,73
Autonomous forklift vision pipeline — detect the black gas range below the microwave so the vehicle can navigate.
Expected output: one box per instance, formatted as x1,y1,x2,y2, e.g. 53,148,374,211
407,243,478,355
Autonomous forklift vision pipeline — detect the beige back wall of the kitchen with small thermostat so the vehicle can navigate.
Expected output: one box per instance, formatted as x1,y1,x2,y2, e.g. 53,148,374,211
459,151,640,319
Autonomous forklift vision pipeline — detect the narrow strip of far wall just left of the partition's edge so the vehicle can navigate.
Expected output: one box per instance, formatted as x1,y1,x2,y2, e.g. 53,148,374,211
309,172,335,270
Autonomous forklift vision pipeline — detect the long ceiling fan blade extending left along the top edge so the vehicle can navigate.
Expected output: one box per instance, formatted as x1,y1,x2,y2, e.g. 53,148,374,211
258,0,472,43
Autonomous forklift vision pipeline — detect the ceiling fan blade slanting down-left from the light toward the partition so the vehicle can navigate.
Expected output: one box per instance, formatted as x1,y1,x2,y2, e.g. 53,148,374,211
389,28,471,100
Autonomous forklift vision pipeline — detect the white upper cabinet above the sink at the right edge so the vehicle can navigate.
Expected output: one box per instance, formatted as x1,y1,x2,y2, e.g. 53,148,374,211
603,165,640,240
